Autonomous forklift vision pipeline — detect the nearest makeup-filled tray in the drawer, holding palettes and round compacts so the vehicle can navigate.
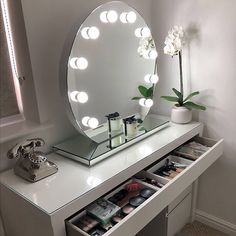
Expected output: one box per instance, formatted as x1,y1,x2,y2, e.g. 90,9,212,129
66,178,160,236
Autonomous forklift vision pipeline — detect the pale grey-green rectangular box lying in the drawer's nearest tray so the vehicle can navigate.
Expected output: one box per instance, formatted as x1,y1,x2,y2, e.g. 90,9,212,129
87,199,120,224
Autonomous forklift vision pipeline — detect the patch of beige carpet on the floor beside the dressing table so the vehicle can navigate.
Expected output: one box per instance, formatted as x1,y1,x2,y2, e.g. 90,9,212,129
176,221,227,236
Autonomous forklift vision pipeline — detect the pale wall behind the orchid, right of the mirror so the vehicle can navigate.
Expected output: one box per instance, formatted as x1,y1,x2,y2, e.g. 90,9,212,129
152,0,236,225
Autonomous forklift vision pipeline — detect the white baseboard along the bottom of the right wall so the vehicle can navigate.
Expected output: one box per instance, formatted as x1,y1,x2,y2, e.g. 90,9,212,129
195,210,236,236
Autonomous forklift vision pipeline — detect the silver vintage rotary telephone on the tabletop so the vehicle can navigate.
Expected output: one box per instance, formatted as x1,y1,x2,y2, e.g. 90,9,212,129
7,138,58,182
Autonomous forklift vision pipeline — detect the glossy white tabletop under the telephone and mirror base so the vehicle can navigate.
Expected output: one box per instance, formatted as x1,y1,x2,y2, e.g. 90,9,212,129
0,122,202,214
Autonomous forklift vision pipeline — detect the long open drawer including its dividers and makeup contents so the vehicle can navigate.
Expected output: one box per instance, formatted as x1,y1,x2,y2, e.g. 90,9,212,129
66,137,223,236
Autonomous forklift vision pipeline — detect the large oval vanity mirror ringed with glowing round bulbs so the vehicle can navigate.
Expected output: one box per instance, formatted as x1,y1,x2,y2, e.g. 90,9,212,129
62,1,158,141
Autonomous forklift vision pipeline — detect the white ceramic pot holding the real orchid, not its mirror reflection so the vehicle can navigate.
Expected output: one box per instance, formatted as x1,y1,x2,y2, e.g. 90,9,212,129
171,106,192,124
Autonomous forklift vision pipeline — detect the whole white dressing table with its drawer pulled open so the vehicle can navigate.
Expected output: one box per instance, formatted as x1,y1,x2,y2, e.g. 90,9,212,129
0,122,223,236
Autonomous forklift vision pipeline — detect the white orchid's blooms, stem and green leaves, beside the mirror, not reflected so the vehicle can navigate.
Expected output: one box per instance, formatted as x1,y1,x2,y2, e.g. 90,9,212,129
161,26,206,110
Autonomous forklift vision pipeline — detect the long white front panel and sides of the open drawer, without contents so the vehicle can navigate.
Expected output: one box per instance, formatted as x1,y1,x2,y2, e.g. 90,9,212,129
66,137,223,236
